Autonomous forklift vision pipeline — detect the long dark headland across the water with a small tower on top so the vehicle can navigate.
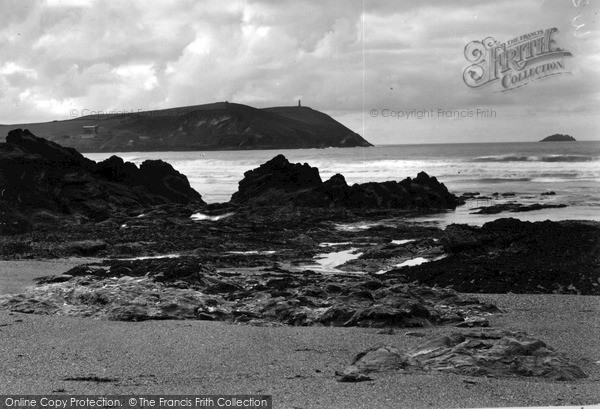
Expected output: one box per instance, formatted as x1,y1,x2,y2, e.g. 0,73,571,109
0,102,372,152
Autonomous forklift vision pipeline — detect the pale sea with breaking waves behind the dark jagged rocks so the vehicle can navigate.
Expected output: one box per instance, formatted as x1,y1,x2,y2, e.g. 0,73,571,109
86,141,600,227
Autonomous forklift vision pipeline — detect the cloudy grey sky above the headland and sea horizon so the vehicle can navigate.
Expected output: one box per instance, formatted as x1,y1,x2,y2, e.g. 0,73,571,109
0,0,600,144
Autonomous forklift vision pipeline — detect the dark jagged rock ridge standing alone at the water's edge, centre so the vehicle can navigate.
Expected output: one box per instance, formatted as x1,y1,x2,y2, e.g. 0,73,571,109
231,155,460,209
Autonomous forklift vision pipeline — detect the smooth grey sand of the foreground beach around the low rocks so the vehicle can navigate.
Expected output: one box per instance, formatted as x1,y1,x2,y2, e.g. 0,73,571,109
0,259,600,408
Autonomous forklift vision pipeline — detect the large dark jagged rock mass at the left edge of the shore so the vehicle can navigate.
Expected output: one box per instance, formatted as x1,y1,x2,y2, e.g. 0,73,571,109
0,129,204,232
